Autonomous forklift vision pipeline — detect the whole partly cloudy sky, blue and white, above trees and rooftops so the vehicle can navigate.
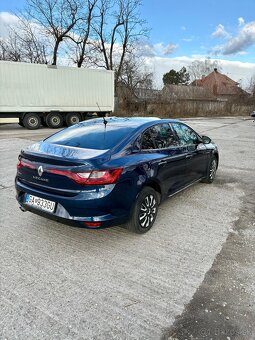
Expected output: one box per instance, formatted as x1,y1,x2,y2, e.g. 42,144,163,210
0,0,255,88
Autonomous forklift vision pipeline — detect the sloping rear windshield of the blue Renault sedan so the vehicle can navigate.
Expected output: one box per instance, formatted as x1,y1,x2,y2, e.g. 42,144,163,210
46,123,133,150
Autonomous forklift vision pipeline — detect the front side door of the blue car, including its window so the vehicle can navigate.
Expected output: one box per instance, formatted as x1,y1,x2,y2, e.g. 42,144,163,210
171,122,210,183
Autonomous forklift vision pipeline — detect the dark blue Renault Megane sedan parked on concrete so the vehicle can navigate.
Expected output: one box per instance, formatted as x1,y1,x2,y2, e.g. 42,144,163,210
15,117,219,233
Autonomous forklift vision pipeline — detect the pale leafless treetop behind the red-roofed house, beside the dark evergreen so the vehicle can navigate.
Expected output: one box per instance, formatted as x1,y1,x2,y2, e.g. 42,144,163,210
187,58,221,81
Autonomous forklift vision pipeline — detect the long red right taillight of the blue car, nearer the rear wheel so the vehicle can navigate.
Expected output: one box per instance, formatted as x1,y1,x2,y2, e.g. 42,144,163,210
47,168,122,185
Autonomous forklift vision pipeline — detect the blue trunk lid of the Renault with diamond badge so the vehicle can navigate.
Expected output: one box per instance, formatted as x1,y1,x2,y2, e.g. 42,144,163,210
17,142,111,194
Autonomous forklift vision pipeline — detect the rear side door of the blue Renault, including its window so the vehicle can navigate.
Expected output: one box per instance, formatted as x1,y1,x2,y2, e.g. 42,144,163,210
141,123,187,195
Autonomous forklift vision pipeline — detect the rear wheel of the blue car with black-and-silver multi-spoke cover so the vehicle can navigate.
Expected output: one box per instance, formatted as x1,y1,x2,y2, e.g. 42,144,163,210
127,187,159,234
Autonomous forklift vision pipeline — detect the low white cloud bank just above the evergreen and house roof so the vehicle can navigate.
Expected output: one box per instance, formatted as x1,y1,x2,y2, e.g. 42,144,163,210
145,56,255,89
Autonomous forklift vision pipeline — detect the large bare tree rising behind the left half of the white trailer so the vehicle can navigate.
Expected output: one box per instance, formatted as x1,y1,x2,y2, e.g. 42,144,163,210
26,0,82,65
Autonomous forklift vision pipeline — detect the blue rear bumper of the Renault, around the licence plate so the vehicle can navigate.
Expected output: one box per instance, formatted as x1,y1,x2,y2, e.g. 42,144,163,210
15,179,129,229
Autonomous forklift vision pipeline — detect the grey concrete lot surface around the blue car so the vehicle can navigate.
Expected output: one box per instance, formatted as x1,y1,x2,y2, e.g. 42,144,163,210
0,118,255,340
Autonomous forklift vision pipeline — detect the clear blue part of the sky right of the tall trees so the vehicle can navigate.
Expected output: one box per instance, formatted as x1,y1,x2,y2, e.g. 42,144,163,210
142,0,255,62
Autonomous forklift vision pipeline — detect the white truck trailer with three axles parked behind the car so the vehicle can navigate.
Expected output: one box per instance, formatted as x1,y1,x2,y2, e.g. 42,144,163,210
0,61,114,129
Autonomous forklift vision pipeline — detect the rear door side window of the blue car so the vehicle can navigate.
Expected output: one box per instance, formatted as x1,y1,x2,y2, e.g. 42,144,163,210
141,123,177,150
